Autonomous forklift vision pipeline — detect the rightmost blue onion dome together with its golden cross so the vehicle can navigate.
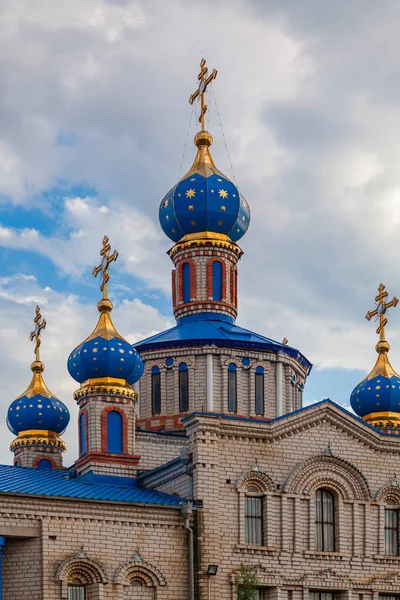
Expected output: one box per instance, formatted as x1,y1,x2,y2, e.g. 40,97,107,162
350,284,400,427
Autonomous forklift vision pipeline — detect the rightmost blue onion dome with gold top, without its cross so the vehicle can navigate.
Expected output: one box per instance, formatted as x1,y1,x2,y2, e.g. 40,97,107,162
350,340,400,423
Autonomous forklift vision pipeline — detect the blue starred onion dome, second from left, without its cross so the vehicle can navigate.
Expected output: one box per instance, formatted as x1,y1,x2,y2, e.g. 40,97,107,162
67,298,144,385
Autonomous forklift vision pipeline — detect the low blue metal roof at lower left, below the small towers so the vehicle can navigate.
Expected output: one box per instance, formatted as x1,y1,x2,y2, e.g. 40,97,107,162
0,465,185,507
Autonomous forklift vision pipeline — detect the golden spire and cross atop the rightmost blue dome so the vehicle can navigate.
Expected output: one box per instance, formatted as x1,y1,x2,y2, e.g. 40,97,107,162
365,283,399,379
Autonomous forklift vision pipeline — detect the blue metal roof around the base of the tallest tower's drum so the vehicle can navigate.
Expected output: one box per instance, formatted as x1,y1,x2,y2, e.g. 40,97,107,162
135,313,312,371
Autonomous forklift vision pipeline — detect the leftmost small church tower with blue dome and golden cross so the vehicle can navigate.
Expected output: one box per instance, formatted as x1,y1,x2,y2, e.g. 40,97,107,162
7,306,70,469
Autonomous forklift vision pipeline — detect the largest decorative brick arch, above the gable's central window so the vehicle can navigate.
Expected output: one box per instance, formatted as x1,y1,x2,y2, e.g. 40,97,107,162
282,449,371,500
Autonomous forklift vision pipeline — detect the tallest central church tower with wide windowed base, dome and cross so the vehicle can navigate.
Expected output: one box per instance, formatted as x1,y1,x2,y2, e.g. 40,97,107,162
136,59,311,431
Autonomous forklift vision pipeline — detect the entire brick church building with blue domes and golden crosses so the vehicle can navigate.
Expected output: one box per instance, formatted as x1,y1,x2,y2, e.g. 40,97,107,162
0,60,400,600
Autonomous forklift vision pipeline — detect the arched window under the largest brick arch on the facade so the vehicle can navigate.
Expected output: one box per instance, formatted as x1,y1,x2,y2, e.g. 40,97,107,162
315,488,335,552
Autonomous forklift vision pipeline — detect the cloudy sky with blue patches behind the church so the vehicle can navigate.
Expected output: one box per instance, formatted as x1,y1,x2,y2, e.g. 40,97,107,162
0,0,400,464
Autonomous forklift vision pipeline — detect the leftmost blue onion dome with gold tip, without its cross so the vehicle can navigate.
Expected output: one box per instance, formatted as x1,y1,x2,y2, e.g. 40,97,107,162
7,360,70,435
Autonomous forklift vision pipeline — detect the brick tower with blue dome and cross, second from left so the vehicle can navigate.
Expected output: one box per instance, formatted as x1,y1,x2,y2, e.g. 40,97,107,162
68,236,143,477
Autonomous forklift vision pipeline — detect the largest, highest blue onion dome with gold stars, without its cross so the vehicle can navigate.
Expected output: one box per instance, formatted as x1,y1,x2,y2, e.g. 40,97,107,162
159,131,250,242
